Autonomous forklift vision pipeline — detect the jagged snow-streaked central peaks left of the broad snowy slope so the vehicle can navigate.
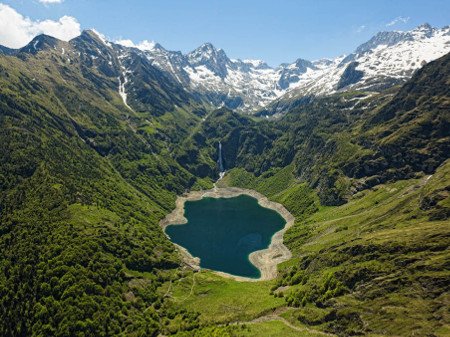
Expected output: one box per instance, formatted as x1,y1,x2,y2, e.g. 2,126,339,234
130,43,280,112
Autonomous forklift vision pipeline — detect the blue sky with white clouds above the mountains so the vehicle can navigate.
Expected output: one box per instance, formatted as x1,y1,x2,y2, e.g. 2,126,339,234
0,0,450,66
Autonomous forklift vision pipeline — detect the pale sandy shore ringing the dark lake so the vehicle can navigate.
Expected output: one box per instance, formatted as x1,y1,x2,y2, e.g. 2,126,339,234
160,187,294,281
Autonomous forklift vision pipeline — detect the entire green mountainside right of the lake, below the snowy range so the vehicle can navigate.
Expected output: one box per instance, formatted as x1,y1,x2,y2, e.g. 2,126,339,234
197,54,450,336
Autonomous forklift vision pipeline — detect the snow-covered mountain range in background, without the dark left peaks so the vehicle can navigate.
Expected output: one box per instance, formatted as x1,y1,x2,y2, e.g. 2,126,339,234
115,24,450,115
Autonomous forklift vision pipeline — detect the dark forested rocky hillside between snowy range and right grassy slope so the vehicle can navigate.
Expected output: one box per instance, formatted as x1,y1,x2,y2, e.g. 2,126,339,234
192,55,450,205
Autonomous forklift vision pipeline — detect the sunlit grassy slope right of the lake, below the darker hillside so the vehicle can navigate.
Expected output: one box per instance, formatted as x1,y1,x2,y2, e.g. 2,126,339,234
225,161,450,336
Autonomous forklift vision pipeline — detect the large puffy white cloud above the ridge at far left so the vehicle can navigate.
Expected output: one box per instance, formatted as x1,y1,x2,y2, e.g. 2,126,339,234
0,3,81,48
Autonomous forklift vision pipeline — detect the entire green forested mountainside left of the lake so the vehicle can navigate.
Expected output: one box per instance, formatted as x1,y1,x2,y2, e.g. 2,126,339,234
0,36,210,336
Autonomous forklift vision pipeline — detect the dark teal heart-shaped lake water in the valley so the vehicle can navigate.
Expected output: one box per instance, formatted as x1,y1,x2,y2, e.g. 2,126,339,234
166,195,286,278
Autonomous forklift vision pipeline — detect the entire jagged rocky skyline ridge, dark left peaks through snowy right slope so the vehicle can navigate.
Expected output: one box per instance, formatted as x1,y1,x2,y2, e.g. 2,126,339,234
0,24,450,115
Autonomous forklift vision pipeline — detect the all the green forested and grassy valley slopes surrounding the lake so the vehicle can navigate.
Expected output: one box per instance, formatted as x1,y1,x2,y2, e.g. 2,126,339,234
0,32,450,336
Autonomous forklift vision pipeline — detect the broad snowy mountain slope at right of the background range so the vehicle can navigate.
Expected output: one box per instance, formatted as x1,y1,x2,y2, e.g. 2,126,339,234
266,24,450,114
